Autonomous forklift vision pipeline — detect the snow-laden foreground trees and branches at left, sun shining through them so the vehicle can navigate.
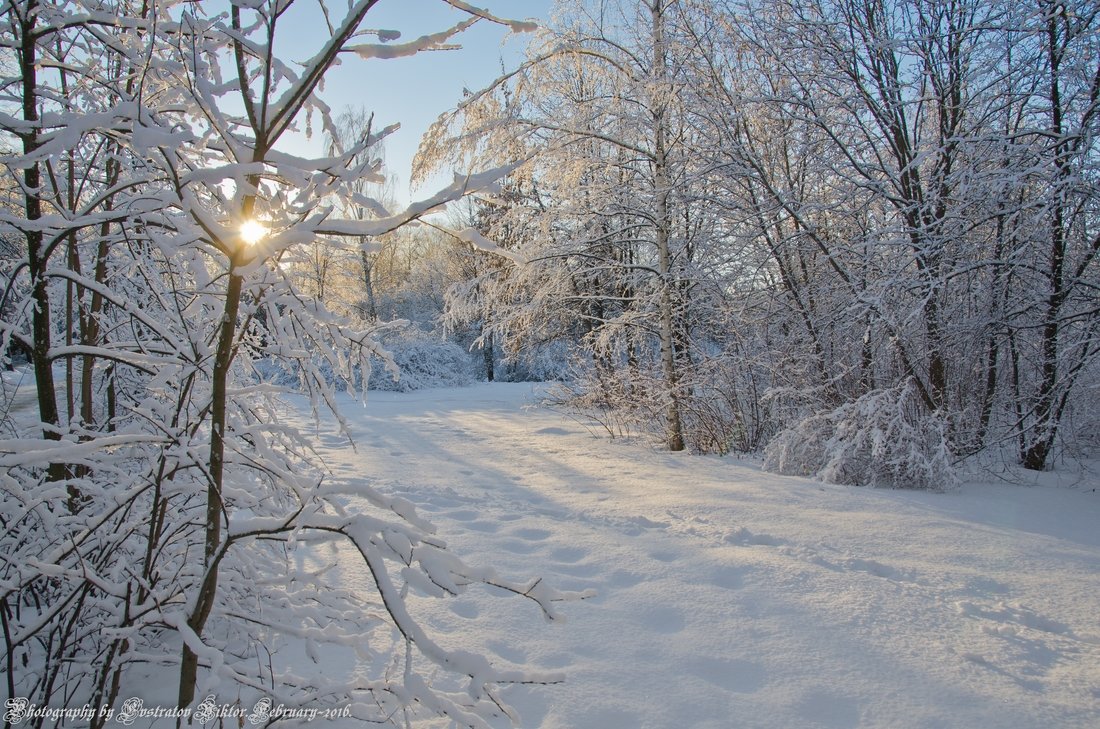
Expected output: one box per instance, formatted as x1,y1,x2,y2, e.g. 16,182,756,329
0,0,594,726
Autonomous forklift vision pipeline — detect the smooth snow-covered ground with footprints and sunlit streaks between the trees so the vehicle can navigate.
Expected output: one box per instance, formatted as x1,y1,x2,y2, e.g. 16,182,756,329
292,384,1100,729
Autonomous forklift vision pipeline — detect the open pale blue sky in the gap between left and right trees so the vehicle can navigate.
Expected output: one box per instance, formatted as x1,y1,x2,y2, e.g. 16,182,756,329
276,0,553,203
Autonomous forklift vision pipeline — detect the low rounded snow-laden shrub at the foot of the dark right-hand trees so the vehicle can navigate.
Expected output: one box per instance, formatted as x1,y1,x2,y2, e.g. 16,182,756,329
765,383,956,490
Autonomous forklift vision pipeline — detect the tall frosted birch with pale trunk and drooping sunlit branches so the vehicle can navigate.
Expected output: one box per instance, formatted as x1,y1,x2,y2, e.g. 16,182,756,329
424,0,743,450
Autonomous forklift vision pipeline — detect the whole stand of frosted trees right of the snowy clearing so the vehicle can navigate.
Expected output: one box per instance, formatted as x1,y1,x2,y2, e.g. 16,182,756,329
424,0,1100,468
